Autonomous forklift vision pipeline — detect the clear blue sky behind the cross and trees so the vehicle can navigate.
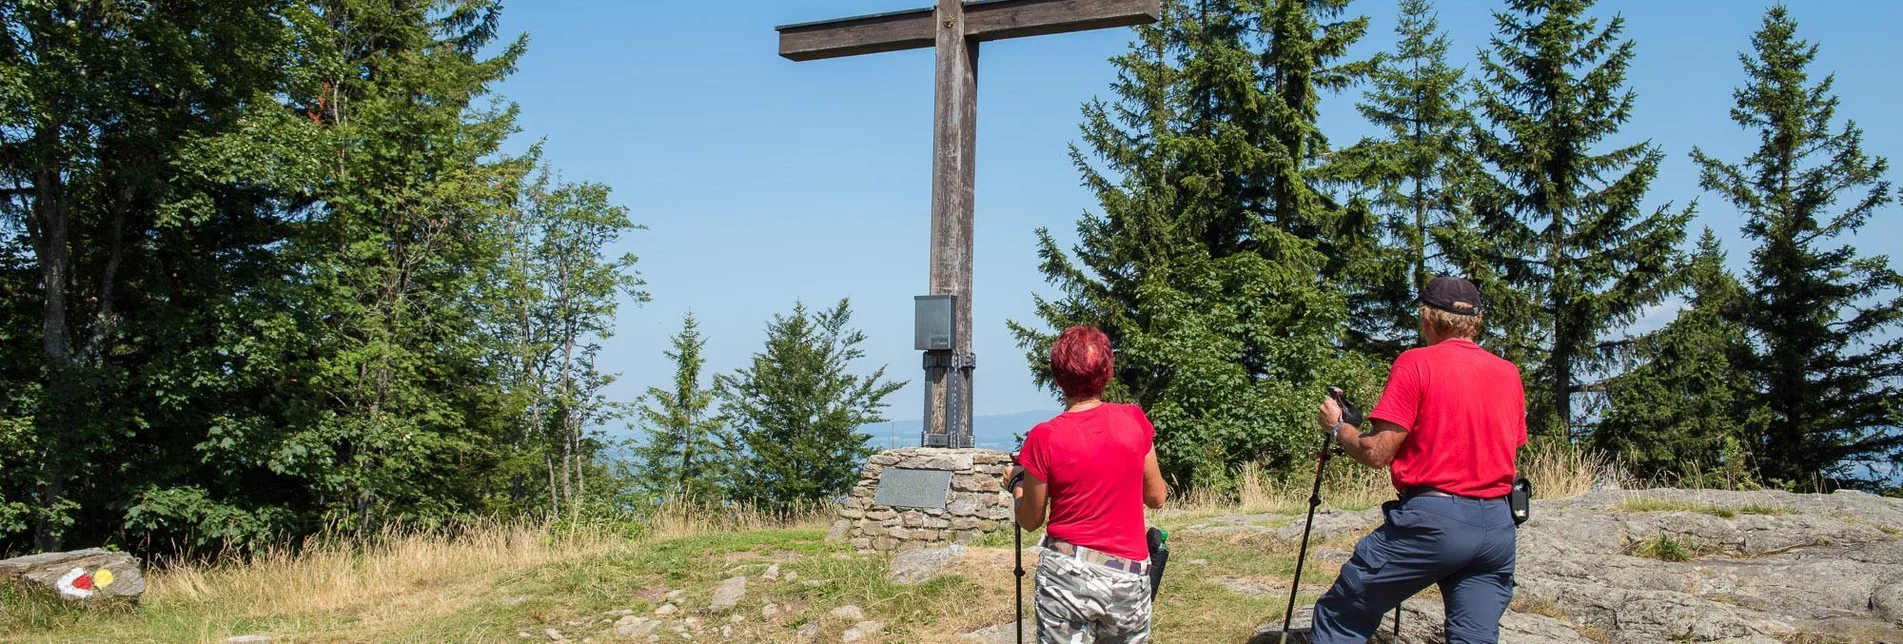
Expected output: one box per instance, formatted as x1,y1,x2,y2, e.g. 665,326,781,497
500,0,1903,426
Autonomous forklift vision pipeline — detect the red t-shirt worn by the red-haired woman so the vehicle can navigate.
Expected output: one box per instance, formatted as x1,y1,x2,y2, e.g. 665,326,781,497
1018,402,1157,560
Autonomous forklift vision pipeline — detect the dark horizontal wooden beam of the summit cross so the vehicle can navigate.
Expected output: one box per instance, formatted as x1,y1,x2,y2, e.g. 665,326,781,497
776,0,1163,61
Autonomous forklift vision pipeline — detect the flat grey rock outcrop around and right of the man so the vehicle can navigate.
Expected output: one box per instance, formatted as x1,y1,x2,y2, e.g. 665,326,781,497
1189,490,1903,644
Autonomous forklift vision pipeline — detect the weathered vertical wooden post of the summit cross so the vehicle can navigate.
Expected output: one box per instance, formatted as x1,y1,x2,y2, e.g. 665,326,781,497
919,0,978,448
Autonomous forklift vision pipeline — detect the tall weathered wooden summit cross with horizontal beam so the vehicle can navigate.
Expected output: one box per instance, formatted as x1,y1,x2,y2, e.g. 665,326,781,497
778,0,1161,448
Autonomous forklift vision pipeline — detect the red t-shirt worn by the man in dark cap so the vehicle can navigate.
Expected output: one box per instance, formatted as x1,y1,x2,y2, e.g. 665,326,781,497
1364,339,1526,499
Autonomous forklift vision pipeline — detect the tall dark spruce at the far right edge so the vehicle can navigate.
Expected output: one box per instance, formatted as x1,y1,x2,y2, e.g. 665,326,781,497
1692,6,1903,484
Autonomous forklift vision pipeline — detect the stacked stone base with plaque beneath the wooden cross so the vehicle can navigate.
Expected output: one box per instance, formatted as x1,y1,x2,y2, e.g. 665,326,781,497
830,448,1010,553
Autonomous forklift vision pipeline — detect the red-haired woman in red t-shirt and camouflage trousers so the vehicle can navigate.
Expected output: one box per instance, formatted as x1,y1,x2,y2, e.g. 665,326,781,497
1014,326,1168,644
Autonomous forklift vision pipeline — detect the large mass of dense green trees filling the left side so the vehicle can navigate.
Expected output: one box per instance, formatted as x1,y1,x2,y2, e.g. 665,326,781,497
0,0,639,551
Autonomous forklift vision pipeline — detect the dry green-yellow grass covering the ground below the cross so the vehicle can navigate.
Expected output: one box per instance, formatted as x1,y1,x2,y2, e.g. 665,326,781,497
0,518,1353,642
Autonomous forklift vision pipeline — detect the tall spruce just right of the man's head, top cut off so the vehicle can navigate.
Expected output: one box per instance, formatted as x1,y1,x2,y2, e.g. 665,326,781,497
1477,0,1692,436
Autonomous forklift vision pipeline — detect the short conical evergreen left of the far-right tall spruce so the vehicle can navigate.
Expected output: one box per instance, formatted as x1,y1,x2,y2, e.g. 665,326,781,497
1591,229,1762,480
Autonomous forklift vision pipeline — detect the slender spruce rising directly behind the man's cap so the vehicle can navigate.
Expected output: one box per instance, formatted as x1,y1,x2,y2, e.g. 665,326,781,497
1330,0,1479,360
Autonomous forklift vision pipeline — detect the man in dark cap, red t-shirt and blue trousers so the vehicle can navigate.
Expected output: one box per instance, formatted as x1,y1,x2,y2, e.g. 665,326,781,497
1311,276,1526,644
